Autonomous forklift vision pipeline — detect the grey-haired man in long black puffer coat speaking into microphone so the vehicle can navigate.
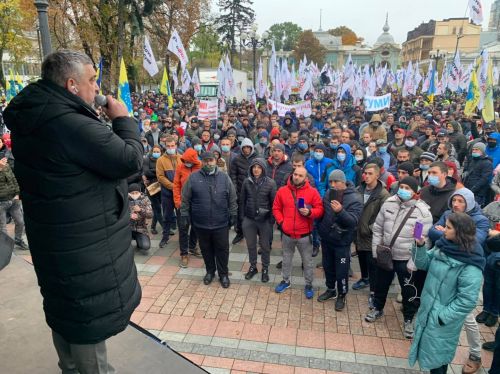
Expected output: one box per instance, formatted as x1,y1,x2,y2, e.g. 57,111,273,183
4,51,143,373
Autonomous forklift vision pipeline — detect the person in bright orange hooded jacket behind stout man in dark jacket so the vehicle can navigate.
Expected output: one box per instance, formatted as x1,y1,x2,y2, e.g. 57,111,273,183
173,148,201,268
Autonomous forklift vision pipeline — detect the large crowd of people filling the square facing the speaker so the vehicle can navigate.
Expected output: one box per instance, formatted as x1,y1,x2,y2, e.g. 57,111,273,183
0,62,500,373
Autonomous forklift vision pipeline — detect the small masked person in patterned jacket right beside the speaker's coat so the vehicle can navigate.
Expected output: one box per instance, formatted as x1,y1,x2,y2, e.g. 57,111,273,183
128,183,153,251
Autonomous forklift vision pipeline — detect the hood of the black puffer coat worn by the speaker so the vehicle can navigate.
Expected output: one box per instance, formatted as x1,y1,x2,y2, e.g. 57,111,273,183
3,79,99,134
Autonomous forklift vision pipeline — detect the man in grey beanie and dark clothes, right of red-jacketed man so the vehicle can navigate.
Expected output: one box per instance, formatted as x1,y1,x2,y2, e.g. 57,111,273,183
318,169,363,311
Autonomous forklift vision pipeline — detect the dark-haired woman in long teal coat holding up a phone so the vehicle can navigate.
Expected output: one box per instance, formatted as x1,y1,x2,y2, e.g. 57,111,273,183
408,213,485,374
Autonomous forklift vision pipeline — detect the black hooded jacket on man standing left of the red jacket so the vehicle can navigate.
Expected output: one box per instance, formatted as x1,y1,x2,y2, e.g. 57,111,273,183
240,158,276,219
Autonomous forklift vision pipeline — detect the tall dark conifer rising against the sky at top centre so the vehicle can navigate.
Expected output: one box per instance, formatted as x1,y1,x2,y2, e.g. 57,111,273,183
216,0,255,65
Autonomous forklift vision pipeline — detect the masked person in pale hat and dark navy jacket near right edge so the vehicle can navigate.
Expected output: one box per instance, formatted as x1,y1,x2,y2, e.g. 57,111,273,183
463,143,493,207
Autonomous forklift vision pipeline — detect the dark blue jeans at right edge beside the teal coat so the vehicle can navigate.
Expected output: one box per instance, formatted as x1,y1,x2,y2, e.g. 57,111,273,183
483,253,500,317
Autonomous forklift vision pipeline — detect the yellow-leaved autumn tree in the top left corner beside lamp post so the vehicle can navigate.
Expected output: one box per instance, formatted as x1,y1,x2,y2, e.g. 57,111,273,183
0,0,34,88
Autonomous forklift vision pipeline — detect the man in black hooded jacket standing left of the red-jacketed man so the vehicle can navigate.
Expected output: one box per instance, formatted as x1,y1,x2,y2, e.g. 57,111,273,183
240,158,276,283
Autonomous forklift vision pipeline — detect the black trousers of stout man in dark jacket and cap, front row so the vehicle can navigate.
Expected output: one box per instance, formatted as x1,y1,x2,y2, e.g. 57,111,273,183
195,227,229,277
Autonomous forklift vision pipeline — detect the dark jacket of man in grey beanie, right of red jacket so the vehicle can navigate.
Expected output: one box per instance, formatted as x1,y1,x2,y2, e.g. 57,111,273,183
318,182,363,246
